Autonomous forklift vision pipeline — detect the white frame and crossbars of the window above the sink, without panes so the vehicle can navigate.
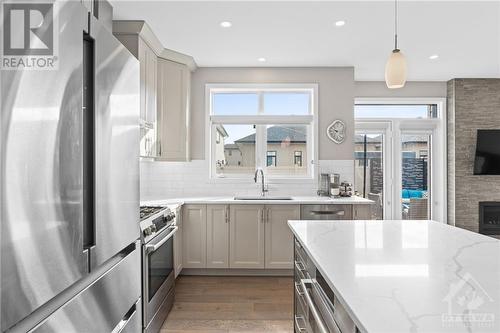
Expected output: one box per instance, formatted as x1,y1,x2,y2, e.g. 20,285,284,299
205,83,318,184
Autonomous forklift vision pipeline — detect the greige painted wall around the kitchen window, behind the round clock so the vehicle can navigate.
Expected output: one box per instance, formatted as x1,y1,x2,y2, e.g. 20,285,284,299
191,67,354,160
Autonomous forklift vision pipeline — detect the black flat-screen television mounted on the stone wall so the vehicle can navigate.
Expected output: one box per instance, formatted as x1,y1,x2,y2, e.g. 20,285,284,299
474,130,500,175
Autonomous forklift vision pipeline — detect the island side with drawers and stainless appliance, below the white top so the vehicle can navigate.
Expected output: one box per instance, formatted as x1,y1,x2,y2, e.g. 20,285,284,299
294,239,359,333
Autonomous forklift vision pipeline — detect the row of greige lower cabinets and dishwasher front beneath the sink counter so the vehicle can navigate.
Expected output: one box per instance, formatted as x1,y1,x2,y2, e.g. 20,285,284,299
180,204,370,269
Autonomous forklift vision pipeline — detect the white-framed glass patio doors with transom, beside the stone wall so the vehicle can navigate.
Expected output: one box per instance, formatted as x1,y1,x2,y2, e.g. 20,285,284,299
354,98,447,222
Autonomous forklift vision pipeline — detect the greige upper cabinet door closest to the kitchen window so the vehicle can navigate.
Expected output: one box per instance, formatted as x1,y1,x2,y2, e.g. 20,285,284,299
158,58,191,161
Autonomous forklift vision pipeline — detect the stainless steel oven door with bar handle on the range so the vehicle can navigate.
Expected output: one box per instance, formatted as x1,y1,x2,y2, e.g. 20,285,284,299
143,225,178,327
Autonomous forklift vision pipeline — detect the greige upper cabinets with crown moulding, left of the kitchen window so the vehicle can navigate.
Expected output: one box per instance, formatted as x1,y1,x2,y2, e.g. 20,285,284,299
113,21,196,161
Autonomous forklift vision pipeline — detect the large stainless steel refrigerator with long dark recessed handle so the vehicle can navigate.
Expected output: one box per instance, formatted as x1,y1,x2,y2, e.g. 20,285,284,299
0,0,141,332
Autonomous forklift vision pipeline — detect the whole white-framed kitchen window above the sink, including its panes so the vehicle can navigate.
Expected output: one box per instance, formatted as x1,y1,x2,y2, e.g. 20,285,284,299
206,84,317,180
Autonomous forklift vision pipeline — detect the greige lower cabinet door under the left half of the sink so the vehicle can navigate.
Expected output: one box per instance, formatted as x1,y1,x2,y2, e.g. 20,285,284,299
229,205,265,268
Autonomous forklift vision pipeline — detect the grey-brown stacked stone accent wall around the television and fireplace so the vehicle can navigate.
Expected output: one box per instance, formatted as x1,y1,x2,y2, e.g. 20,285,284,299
447,79,500,232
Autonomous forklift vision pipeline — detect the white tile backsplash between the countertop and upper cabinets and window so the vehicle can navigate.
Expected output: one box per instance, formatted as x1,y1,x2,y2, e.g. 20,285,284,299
140,160,354,201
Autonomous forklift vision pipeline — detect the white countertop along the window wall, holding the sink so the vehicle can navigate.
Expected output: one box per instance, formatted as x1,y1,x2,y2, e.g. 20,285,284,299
141,195,373,206
